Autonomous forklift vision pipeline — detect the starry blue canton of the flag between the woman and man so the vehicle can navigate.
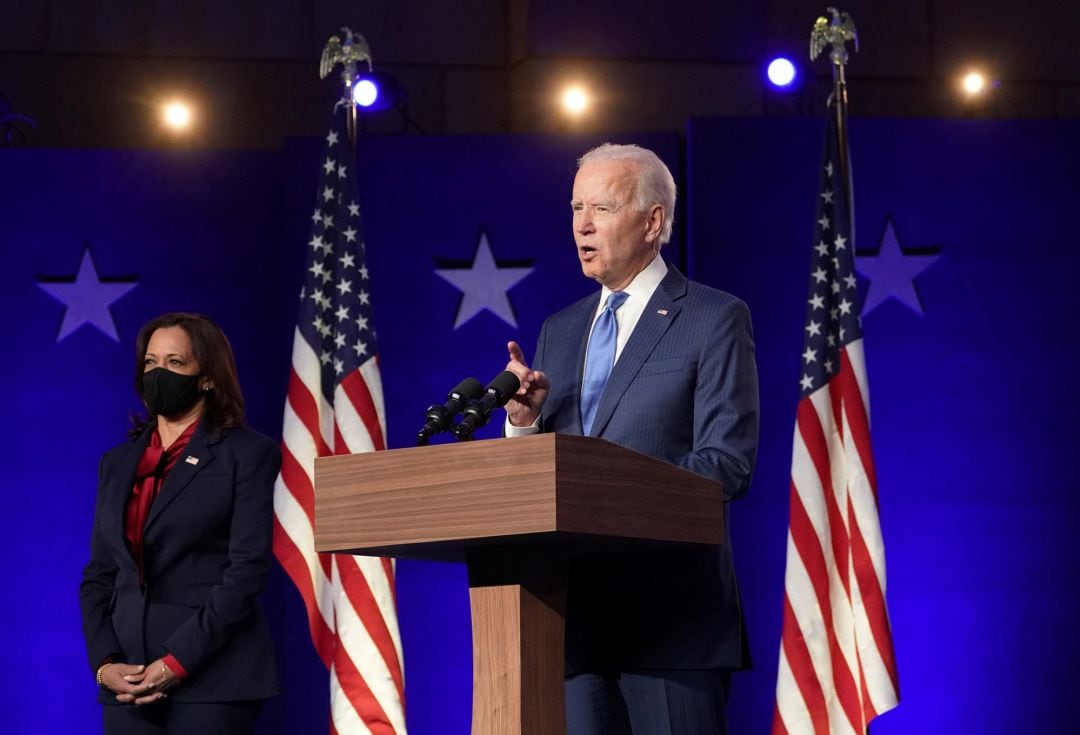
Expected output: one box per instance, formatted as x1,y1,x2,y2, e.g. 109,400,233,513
298,107,378,404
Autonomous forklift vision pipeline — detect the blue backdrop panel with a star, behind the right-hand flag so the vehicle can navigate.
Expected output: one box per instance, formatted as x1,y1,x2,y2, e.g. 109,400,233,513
687,119,1080,735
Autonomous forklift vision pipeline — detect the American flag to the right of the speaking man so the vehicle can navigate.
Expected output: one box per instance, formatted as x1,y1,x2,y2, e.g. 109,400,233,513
772,110,900,735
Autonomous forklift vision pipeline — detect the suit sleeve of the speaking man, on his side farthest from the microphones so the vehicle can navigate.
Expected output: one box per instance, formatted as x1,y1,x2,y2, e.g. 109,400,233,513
675,301,758,500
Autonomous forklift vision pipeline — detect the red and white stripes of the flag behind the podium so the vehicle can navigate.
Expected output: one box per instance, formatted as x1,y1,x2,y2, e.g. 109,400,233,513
274,330,406,735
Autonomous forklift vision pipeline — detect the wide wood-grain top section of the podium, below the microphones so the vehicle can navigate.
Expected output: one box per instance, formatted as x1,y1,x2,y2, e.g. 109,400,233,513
315,434,724,560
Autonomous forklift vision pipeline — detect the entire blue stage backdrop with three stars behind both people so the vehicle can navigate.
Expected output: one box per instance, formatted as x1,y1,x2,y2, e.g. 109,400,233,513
0,119,1080,735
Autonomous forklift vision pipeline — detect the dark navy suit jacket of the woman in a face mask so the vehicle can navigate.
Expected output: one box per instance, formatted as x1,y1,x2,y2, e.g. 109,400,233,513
79,424,281,704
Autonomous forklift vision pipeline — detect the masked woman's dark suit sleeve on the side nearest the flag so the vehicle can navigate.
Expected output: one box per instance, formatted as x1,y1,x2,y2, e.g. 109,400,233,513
164,439,281,675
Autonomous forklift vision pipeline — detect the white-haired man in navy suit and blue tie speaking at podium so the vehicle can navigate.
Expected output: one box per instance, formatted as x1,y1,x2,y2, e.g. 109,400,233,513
507,145,758,735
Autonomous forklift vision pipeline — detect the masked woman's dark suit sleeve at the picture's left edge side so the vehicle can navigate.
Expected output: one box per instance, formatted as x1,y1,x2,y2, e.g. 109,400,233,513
79,457,123,670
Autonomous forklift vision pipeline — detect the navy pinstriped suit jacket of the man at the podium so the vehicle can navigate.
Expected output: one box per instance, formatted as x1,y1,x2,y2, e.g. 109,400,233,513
534,266,758,675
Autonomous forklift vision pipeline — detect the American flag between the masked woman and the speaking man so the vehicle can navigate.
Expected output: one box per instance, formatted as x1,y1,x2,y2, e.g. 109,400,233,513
273,106,405,735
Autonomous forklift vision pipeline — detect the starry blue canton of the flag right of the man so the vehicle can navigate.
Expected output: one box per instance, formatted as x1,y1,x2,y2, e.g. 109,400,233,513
799,114,862,396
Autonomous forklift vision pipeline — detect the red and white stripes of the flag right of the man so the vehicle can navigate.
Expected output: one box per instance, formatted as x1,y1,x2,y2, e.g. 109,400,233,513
772,339,900,735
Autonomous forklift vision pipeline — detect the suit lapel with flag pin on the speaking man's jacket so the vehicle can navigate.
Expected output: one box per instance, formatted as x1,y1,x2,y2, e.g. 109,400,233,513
578,264,686,436
